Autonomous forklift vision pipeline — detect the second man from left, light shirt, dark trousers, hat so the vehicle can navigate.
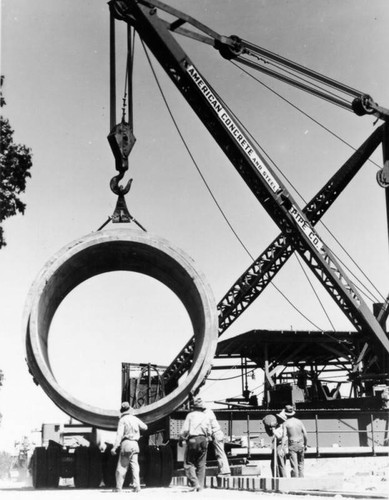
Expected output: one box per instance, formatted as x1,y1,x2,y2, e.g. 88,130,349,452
179,398,212,491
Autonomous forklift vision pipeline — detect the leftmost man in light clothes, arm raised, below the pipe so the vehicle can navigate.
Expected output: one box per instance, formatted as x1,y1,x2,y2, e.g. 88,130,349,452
111,401,147,493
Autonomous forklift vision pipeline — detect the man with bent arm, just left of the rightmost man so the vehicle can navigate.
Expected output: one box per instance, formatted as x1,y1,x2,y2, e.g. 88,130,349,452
263,412,288,477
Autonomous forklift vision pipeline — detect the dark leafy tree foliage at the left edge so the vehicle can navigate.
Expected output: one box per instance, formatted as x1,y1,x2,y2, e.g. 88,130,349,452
0,76,32,248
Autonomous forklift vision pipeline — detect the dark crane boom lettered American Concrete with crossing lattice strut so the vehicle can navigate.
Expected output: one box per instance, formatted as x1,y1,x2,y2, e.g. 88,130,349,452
109,0,389,387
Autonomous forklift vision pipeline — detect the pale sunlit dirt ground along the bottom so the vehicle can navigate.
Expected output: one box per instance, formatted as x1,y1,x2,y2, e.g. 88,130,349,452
0,456,389,500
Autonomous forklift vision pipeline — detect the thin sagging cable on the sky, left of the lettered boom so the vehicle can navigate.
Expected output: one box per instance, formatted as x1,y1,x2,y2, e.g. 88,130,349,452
142,41,322,331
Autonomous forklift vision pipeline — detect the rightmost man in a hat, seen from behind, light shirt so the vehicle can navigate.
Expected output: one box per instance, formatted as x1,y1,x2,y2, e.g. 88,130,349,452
282,405,308,477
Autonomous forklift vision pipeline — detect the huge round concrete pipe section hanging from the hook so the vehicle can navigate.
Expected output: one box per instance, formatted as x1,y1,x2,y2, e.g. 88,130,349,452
25,229,218,430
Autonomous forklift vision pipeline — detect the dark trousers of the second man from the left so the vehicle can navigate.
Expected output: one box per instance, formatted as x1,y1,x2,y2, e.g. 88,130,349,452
184,436,208,490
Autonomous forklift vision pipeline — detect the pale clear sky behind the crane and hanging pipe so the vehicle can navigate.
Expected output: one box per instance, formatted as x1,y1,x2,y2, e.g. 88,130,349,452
0,0,389,450
